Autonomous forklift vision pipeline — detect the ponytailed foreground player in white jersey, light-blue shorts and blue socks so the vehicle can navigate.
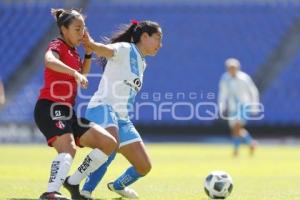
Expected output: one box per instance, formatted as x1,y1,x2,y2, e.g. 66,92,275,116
81,20,162,199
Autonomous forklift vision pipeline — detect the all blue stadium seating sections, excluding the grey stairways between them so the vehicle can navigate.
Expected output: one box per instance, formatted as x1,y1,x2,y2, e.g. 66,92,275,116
0,0,300,125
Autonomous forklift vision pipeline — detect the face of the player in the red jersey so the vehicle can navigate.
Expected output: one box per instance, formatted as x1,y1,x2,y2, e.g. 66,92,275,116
63,16,85,47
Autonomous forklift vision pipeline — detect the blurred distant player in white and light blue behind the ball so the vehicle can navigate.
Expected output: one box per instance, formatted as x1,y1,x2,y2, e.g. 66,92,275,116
218,58,259,156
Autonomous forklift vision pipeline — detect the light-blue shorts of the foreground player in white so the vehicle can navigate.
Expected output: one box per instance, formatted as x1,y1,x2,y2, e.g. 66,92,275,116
85,104,142,147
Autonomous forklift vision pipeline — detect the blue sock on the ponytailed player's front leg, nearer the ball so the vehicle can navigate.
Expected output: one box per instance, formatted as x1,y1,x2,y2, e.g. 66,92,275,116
114,166,142,190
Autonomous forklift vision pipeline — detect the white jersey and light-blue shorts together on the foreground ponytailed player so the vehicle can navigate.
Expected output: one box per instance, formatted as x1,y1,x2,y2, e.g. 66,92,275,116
86,42,146,146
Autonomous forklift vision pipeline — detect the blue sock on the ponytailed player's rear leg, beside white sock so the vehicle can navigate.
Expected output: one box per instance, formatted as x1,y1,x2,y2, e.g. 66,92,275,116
82,152,116,192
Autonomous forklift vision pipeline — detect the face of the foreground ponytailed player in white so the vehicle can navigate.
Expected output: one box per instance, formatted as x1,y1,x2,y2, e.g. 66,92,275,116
144,28,162,56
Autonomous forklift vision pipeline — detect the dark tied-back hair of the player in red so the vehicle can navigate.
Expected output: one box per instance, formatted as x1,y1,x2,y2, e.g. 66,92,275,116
51,8,84,35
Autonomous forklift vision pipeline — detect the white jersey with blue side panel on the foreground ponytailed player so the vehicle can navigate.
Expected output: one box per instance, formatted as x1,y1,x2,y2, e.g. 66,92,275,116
88,42,146,119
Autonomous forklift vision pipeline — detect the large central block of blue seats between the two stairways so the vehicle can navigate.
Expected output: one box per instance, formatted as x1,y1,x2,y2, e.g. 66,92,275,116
83,1,299,125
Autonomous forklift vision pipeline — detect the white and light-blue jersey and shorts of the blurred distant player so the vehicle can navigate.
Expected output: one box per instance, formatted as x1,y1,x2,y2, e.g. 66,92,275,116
218,71,259,126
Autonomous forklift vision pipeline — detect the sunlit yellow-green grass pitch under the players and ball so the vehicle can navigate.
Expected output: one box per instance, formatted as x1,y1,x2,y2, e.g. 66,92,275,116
0,143,300,200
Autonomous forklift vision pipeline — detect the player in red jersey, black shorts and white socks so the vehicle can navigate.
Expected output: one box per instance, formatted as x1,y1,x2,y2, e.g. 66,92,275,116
34,9,117,200
